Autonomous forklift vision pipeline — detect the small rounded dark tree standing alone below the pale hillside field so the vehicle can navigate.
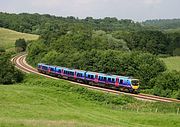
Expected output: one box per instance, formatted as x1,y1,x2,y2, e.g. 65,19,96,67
15,39,27,52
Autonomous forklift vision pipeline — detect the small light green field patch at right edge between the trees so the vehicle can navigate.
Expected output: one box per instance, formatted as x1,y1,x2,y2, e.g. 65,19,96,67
162,56,180,71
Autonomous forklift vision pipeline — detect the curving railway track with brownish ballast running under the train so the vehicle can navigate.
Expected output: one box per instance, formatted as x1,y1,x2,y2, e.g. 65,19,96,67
11,53,180,103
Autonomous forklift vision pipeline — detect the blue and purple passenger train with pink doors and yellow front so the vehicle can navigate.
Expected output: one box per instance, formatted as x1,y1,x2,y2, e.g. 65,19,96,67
37,63,139,93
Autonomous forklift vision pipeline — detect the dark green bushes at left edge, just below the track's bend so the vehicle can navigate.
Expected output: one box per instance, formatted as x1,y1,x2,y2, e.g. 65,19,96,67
0,53,24,84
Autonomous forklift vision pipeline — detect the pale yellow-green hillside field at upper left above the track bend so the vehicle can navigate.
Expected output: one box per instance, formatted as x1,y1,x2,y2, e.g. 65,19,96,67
0,28,39,49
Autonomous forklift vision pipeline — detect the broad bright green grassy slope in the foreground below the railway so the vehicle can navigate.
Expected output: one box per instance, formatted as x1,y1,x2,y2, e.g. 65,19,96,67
0,76,180,127
